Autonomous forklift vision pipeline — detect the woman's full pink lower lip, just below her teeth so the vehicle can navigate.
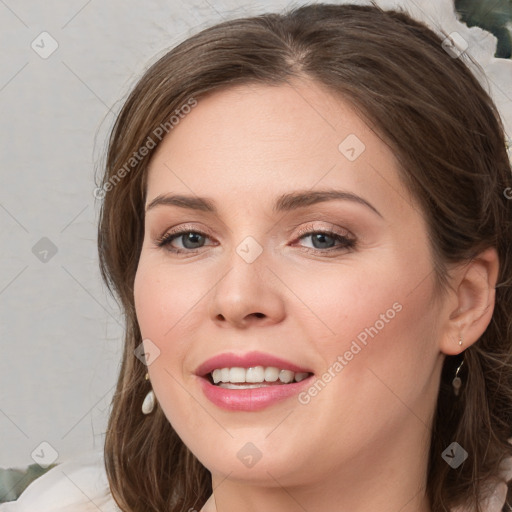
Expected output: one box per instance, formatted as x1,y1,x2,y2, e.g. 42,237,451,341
198,375,314,411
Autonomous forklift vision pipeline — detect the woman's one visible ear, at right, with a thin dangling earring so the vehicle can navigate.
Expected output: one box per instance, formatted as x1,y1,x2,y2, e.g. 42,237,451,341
439,247,499,355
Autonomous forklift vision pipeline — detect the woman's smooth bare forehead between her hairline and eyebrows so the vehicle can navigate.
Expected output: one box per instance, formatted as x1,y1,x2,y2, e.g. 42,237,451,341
147,82,412,220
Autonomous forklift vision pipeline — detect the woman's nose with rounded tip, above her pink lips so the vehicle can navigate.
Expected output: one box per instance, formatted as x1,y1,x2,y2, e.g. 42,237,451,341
210,247,285,329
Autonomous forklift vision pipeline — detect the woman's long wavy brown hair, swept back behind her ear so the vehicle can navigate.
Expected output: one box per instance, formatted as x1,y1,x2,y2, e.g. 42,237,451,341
98,4,512,512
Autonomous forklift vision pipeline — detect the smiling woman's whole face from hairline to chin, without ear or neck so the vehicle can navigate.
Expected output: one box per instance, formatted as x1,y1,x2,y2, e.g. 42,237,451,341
135,82,448,486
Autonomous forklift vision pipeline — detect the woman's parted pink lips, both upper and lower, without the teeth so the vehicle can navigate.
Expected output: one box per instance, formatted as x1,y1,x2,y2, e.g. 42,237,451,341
195,352,314,411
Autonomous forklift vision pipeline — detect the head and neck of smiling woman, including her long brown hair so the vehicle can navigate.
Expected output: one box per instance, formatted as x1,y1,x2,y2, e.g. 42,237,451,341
2,4,512,512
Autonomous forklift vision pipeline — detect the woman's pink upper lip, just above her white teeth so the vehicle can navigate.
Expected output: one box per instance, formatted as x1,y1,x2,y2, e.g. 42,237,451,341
195,352,313,377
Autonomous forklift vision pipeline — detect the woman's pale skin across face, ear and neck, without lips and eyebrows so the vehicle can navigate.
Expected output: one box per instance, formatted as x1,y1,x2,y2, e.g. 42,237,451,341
134,81,498,512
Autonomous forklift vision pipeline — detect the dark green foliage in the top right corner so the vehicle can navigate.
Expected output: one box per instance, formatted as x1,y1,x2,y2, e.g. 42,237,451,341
455,0,512,59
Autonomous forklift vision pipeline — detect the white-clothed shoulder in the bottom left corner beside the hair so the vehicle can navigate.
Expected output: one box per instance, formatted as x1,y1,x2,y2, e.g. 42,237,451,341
0,451,121,512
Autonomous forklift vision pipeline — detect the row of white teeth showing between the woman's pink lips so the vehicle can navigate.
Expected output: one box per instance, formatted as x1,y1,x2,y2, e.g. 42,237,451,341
211,366,310,389
